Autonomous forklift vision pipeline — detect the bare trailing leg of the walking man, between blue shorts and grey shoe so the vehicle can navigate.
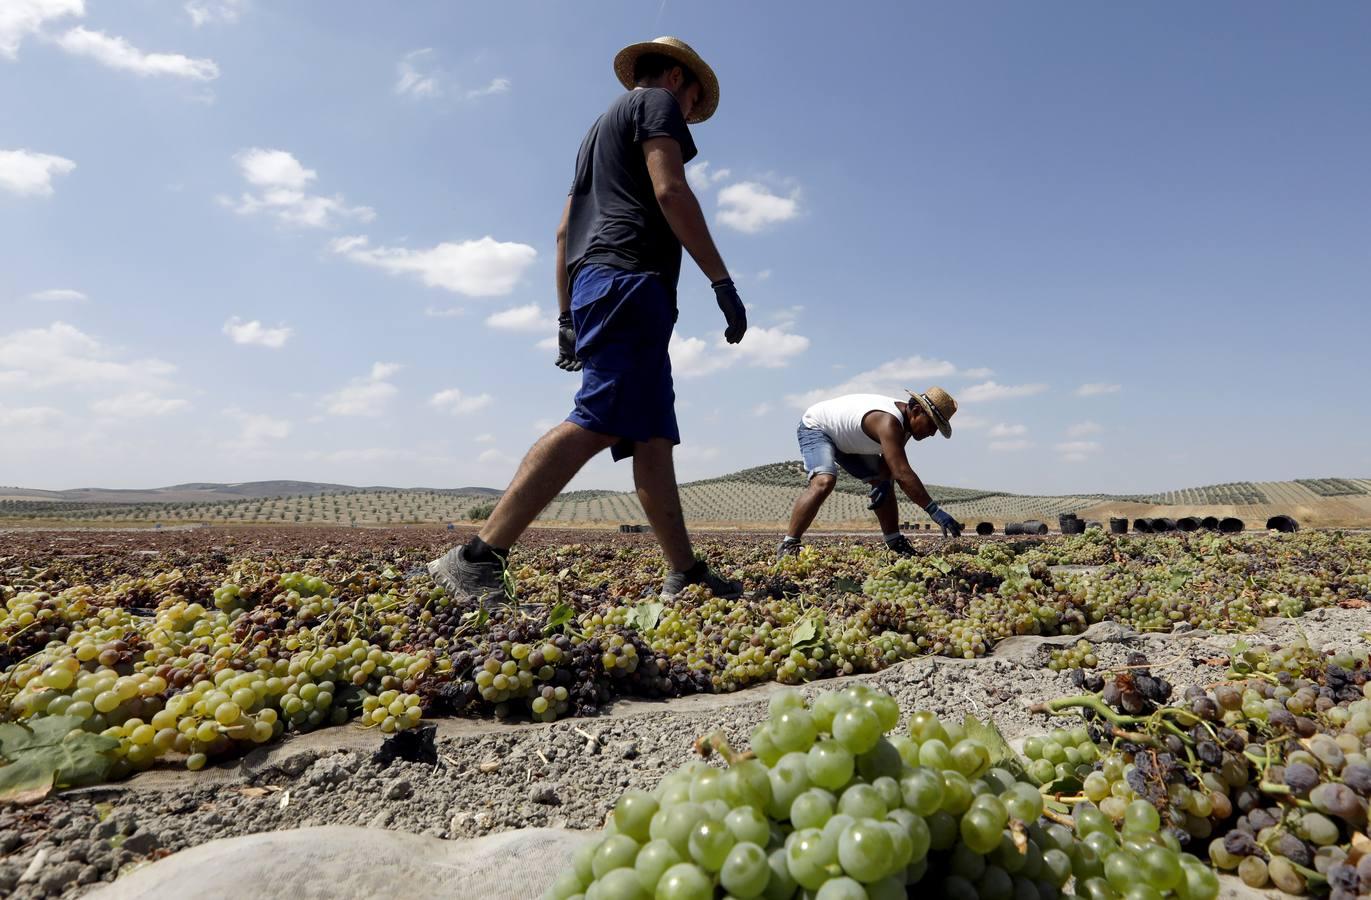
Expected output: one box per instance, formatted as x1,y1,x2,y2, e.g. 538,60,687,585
480,421,618,550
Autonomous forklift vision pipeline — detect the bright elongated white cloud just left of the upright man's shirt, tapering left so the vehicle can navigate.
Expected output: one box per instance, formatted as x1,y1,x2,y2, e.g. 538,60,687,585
332,236,537,296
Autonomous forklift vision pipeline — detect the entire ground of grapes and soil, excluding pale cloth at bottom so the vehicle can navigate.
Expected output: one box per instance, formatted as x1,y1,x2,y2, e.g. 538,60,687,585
0,526,1371,900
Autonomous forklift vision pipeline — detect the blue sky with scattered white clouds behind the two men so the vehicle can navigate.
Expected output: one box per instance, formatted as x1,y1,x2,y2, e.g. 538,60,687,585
0,0,1371,493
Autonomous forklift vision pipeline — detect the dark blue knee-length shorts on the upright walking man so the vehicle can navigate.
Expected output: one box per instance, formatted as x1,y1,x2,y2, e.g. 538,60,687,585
566,265,681,460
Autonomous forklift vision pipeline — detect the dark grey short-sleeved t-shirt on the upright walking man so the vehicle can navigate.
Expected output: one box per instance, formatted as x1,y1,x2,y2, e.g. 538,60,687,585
566,88,696,296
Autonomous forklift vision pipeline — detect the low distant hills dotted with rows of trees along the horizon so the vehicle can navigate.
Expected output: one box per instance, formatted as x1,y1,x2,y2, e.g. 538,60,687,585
0,471,1371,527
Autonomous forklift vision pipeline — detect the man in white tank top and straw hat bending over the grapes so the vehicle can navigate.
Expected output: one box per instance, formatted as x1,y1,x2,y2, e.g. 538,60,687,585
777,387,962,556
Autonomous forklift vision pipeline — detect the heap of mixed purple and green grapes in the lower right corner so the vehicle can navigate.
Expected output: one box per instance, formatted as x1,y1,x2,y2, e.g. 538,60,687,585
1024,641,1371,900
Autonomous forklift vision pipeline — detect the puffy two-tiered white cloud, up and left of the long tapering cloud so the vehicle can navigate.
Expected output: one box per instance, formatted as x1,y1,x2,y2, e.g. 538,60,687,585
219,147,376,228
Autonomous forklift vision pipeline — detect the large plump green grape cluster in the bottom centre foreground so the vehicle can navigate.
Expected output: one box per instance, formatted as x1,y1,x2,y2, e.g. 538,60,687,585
546,686,1219,900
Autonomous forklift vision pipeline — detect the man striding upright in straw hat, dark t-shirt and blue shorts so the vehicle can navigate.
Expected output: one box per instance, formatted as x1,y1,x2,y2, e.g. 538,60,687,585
428,37,747,598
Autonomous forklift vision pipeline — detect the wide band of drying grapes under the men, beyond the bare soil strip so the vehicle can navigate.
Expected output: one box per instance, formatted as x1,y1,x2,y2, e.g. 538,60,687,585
0,531,1371,777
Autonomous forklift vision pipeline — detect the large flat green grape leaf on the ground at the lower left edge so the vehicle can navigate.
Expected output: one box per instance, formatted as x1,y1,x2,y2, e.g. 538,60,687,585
0,716,119,803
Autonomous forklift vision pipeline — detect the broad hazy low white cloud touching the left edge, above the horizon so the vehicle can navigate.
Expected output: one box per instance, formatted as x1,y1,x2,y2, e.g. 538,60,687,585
0,322,175,391
